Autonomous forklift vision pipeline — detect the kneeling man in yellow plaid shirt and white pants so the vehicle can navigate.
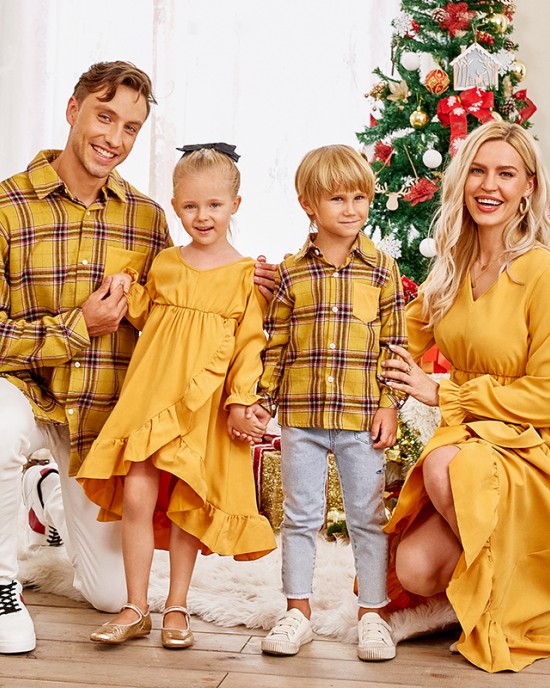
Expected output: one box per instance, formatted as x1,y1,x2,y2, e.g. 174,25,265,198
0,61,280,653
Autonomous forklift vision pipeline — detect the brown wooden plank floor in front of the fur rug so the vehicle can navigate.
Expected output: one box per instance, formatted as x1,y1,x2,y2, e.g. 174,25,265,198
4,590,550,688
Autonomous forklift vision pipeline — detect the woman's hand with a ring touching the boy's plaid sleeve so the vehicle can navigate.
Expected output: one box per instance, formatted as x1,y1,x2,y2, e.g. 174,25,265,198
379,344,439,406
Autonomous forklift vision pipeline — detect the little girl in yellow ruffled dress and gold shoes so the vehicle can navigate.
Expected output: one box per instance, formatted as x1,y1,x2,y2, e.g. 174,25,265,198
77,144,275,648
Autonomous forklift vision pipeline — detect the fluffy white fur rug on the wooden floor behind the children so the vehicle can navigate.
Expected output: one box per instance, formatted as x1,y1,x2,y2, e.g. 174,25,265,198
19,537,456,642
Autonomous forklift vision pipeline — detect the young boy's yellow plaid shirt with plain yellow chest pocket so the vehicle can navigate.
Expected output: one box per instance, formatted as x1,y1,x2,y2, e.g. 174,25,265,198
259,233,406,430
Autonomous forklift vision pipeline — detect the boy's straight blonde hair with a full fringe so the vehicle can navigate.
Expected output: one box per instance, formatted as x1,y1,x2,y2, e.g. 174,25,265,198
295,144,374,208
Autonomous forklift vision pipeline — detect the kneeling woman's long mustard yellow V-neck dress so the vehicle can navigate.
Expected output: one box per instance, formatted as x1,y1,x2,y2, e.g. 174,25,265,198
387,249,550,672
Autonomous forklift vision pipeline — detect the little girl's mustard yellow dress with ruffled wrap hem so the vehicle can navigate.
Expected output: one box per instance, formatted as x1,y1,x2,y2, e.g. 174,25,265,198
77,247,276,559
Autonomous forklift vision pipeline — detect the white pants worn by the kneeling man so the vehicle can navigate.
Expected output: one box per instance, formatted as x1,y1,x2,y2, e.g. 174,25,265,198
0,378,126,612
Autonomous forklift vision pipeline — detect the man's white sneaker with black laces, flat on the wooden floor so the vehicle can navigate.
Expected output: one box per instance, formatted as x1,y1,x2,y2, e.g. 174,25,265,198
0,580,36,654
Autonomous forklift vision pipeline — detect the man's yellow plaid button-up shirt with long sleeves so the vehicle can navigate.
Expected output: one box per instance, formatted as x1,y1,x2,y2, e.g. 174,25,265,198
0,151,169,473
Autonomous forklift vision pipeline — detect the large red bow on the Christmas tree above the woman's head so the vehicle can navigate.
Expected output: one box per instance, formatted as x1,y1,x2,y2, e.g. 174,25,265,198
437,87,494,155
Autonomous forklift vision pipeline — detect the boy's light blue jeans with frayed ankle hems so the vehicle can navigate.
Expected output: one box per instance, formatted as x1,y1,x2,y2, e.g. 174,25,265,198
281,427,389,609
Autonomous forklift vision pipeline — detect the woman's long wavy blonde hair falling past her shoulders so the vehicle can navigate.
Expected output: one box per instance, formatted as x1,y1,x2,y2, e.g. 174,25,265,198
422,120,550,327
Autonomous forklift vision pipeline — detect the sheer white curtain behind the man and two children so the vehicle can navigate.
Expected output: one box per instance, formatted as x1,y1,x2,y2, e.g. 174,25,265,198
0,0,400,261
